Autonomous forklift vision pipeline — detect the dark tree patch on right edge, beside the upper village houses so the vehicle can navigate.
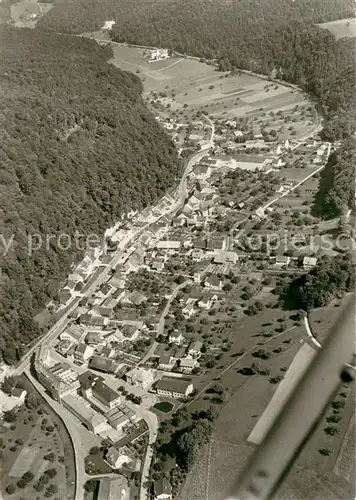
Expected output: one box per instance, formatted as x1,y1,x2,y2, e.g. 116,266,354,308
312,137,356,219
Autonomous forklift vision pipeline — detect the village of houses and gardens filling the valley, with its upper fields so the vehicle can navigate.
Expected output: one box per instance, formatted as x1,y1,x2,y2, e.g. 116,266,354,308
1,30,354,500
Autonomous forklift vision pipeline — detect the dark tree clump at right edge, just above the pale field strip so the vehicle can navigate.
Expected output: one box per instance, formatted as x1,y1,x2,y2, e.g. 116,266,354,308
275,254,355,312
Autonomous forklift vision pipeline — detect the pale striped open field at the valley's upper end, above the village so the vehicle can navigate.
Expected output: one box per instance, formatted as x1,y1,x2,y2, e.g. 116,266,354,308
106,46,315,138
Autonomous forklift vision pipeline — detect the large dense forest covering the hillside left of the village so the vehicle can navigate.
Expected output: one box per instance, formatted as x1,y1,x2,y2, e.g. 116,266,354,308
0,26,177,363
